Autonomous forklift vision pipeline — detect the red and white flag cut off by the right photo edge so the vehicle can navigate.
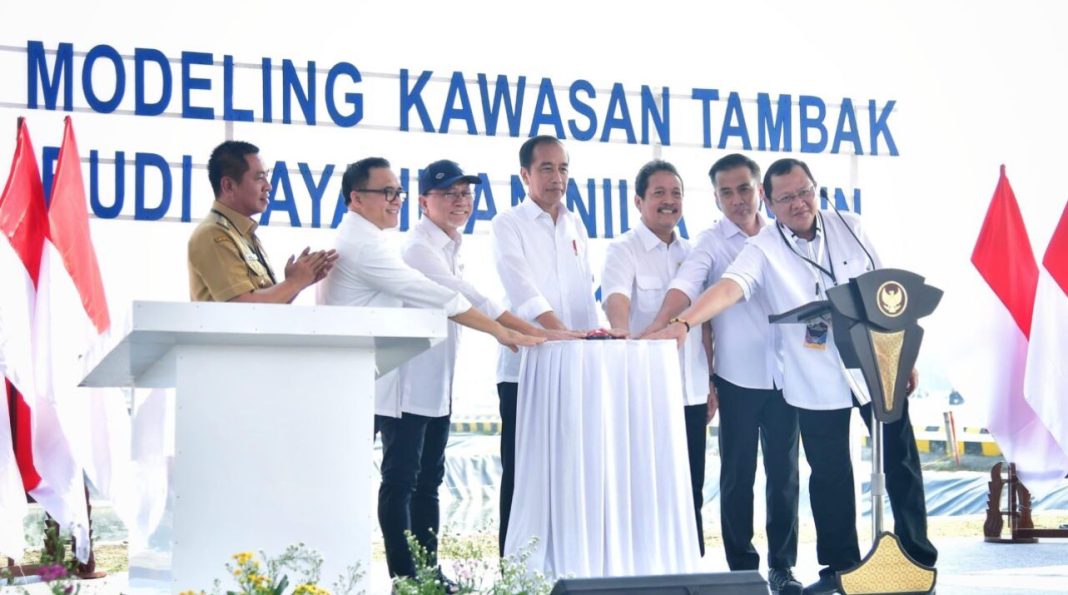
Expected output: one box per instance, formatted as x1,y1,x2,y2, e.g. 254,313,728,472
1024,204,1068,465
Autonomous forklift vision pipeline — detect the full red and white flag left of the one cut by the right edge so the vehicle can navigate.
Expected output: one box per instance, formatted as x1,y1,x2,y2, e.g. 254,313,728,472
969,166,1068,496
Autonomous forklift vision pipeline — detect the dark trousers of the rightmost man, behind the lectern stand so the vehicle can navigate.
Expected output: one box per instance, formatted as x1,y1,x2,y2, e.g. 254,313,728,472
798,400,938,575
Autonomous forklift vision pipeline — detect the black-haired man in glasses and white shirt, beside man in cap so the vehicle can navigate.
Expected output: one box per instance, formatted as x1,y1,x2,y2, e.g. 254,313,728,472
318,157,544,577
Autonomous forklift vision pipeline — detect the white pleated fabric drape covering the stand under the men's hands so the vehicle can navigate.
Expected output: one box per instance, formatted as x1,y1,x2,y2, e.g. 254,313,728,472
505,341,700,577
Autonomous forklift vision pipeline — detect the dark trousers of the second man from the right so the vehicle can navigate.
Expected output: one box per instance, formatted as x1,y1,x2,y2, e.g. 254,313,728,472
712,376,799,570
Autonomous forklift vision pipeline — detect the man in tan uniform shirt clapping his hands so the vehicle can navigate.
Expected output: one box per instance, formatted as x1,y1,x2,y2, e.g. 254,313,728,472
188,141,337,303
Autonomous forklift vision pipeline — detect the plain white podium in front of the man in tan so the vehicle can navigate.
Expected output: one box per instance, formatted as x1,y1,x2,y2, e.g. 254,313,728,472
82,302,445,593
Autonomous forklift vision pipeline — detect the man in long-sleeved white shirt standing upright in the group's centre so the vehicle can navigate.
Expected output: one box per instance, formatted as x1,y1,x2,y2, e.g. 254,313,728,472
492,136,597,555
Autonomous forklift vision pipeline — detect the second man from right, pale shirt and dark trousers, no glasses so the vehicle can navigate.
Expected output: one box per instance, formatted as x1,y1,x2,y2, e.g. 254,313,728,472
640,153,801,594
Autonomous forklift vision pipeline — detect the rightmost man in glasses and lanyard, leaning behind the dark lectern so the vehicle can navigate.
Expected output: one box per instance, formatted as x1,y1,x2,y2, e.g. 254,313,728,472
651,158,938,593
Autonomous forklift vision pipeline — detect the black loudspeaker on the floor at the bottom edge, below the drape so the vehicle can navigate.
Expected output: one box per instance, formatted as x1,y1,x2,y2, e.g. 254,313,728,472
550,570,768,595
